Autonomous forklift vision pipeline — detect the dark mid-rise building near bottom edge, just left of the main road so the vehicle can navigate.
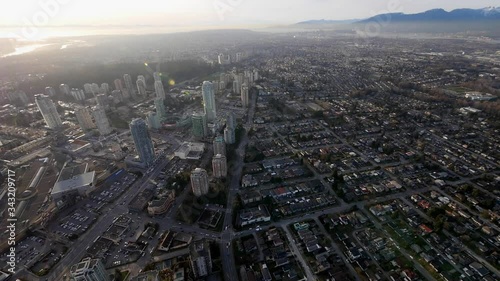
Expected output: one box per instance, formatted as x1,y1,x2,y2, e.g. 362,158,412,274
189,239,212,278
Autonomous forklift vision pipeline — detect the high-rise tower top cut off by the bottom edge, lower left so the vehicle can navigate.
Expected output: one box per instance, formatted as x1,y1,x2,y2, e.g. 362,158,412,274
70,258,110,281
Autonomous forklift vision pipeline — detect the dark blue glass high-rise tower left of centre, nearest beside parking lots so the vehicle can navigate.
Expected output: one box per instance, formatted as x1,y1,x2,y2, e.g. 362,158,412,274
130,118,155,167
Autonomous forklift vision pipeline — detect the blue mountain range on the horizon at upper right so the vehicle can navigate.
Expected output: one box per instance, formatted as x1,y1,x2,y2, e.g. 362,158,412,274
357,7,500,23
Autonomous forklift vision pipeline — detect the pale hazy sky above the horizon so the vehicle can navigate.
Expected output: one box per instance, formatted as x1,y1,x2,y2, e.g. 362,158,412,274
0,0,500,27
